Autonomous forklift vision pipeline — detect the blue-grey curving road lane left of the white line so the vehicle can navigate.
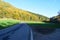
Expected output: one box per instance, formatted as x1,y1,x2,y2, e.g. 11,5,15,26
0,24,33,40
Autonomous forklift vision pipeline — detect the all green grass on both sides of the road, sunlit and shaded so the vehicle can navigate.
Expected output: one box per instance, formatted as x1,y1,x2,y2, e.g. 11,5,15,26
0,19,60,29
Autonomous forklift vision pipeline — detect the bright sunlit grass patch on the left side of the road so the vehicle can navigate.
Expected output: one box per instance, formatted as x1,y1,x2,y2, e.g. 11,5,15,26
0,19,20,29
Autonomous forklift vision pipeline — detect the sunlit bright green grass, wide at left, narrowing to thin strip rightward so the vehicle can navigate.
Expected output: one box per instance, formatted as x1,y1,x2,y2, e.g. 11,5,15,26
0,18,44,29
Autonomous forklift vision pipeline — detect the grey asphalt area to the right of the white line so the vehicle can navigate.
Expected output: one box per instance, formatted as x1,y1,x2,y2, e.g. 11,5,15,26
34,28,60,40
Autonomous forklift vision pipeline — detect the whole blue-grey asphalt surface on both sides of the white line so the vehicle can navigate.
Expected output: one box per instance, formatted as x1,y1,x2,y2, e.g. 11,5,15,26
0,23,60,40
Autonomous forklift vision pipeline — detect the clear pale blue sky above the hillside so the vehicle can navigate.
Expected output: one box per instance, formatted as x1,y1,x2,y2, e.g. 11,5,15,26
4,0,60,17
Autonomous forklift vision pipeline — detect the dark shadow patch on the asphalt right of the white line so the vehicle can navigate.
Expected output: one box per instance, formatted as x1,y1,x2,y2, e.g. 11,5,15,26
35,28,56,35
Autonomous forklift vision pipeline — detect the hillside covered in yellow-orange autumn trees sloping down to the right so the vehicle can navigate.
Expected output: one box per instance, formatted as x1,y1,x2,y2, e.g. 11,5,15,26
0,1,49,21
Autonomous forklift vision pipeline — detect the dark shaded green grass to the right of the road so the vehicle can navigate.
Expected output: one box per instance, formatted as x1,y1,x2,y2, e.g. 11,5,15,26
27,23,60,28
